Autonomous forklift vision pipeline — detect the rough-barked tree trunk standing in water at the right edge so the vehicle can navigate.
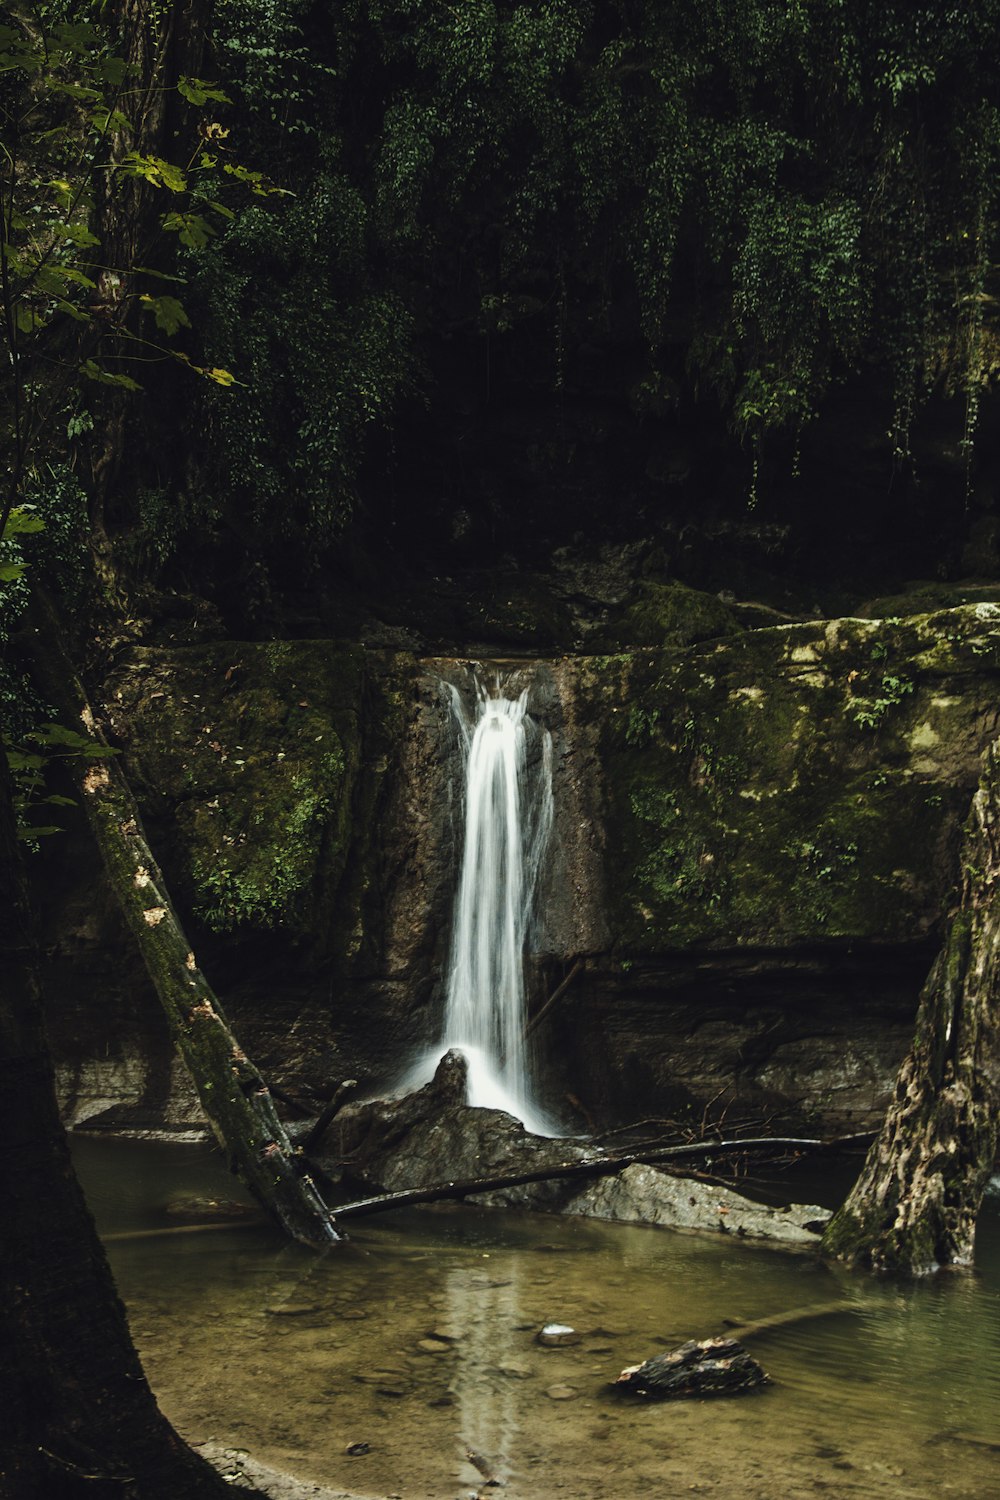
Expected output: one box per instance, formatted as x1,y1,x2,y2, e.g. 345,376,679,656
823,740,1000,1275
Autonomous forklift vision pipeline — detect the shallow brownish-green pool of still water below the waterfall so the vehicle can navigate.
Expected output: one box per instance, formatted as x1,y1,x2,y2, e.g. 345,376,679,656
75,1140,1000,1500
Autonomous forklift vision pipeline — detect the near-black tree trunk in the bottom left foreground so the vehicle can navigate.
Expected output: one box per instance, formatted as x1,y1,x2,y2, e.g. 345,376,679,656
0,755,229,1500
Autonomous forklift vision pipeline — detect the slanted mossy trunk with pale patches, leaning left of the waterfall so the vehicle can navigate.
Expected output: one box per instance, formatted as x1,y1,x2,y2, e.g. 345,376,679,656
28,588,340,1245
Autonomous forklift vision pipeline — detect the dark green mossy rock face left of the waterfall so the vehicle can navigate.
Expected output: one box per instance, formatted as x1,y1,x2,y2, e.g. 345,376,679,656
96,641,401,935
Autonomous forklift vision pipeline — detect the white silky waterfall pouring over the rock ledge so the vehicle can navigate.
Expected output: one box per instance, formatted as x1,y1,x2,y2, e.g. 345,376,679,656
442,680,552,1134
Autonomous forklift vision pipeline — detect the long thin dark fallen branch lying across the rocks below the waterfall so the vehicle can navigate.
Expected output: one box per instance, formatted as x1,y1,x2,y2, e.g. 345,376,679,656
329,1136,858,1223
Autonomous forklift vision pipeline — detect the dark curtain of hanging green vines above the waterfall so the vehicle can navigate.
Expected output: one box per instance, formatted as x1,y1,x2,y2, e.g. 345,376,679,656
164,0,1000,567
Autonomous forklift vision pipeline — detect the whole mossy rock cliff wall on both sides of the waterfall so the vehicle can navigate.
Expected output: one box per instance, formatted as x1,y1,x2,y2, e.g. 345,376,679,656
46,588,1000,1128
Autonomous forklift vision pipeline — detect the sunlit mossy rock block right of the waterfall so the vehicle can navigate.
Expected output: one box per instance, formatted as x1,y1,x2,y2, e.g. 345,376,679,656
582,603,1000,954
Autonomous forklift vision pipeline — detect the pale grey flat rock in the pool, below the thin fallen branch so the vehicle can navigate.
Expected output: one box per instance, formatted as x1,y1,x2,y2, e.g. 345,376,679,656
564,1164,831,1245
